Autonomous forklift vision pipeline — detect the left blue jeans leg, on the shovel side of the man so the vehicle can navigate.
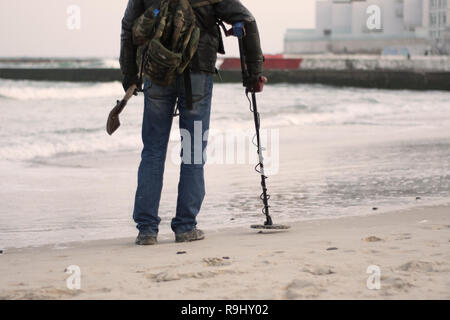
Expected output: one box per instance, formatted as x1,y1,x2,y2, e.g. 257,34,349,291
133,81,177,236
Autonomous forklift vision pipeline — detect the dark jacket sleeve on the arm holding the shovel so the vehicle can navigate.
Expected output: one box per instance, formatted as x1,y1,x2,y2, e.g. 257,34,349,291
119,0,145,76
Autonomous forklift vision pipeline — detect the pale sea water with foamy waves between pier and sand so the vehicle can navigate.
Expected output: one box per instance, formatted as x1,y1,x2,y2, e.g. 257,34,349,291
0,80,450,248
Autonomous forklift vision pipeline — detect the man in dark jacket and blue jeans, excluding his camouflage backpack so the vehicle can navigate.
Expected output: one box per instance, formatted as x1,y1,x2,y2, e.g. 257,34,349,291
120,0,264,245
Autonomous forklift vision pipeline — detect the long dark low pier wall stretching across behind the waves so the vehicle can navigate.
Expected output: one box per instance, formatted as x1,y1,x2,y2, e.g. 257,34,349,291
0,68,450,91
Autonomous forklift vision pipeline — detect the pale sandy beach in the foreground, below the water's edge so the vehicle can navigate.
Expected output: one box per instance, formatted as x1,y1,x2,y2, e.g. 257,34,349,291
0,202,450,299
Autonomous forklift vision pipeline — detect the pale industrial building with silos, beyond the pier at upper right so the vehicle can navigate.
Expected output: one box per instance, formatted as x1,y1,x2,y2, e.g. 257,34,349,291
285,0,450,55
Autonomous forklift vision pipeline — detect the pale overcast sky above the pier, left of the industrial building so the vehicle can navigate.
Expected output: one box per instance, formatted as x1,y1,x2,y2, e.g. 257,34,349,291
0,0,315,57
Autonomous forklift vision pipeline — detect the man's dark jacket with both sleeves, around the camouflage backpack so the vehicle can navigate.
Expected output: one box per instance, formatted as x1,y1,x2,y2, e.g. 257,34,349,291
120,0,263,76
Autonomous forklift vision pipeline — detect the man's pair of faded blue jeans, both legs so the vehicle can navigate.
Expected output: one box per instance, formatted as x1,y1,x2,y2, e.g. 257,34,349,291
133,73,213,235
